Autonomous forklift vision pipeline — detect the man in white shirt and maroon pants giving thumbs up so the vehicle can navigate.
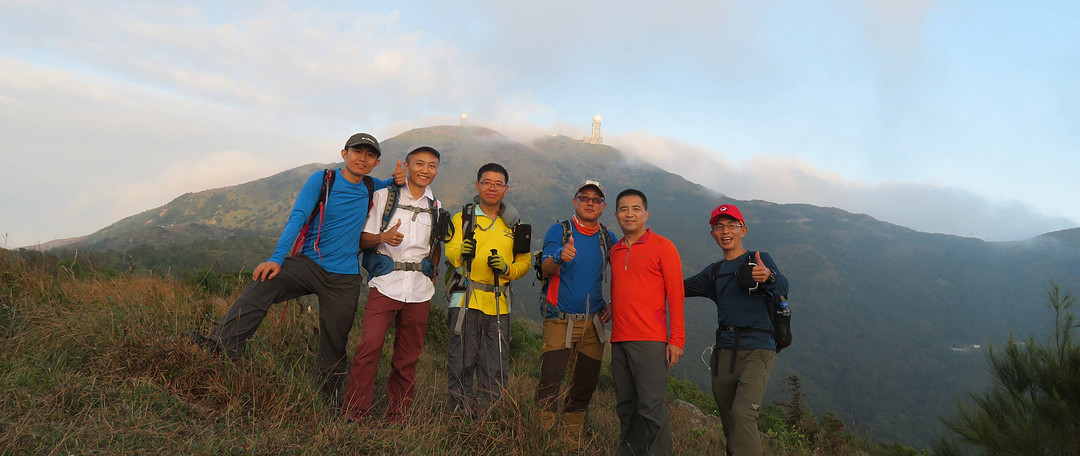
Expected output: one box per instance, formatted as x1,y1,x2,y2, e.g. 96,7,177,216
343,146,448,423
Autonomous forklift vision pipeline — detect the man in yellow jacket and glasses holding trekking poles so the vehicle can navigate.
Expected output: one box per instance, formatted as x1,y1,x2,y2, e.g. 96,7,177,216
446,163,530,414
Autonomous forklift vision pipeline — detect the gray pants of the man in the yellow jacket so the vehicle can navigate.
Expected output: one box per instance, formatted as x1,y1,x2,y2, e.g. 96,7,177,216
446,307,510,413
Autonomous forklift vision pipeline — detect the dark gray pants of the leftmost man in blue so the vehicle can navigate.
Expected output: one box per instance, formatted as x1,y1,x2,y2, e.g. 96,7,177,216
211,255,364,374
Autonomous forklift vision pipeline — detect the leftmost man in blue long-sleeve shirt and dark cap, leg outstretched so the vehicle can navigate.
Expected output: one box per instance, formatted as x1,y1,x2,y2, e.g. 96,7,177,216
187,133,404,394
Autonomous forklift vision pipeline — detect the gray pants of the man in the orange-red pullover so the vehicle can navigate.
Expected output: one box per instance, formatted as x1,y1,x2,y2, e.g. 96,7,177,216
611,340,673,456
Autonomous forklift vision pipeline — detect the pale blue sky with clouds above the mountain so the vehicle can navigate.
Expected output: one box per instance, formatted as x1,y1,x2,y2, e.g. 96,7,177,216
0,0,1080,247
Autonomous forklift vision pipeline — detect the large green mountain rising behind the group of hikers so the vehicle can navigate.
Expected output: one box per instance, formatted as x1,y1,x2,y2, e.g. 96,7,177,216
48,126,1080,445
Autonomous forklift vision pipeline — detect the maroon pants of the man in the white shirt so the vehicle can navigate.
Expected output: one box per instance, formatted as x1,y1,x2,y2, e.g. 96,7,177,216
345,289,431,420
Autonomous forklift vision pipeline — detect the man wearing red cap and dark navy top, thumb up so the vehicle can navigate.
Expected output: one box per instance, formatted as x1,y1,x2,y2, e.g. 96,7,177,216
683,204,787,456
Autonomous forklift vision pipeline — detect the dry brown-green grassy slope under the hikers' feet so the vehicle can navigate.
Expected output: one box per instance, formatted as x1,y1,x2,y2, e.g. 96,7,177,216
0,251,928,455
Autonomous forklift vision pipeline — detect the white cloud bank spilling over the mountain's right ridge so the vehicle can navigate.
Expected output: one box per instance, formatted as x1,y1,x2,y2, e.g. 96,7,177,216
608,132,1077,241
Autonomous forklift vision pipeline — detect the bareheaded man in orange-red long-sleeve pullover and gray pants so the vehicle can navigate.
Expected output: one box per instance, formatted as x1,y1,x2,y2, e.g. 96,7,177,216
610,189,686,455
